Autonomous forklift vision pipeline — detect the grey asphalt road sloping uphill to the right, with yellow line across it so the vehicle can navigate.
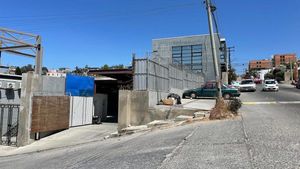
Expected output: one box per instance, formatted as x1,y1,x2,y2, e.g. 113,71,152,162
0,86,300,169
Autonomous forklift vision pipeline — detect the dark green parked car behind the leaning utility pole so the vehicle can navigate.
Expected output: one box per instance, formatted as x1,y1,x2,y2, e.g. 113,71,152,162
182,82,241,99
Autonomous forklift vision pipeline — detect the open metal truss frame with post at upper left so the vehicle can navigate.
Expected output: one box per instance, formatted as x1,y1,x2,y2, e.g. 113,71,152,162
0,28,43,74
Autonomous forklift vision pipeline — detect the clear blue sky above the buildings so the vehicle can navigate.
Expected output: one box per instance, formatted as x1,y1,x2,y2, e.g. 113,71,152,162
0,0,300,73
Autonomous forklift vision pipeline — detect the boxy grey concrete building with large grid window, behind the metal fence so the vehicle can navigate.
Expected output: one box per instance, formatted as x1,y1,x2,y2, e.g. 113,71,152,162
152,34,227,81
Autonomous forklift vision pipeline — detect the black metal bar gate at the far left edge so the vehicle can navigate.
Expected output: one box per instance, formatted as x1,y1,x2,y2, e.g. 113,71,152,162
0,104,20,146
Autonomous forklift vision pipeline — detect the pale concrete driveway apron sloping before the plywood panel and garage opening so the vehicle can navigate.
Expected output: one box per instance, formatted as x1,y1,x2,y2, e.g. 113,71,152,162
0,123,118,157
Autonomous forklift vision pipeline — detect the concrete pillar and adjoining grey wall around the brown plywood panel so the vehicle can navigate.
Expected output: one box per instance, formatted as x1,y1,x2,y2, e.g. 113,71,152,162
17,72,65,146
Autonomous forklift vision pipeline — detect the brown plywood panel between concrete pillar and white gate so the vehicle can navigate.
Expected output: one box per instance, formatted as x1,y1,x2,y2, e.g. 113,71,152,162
31,96,70,133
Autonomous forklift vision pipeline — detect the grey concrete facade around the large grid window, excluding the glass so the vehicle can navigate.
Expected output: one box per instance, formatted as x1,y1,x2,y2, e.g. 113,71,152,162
152,35,221,81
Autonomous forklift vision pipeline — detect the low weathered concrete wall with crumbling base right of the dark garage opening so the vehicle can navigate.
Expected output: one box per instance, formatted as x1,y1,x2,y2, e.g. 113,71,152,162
118,90,199,131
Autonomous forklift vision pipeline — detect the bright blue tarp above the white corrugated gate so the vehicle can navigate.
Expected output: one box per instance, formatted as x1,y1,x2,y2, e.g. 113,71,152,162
66,74,94,97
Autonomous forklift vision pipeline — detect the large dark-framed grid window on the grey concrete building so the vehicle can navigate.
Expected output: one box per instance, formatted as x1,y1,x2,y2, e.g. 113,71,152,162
172,45,202,72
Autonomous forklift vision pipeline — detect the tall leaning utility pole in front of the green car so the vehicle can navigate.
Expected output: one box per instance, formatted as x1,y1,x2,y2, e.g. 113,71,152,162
205,0,222,99
